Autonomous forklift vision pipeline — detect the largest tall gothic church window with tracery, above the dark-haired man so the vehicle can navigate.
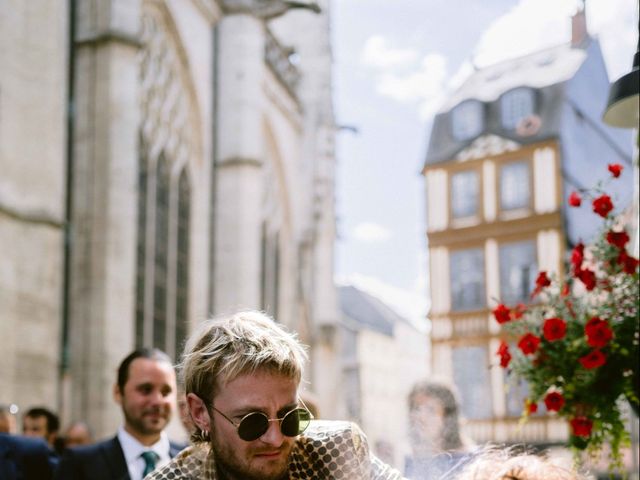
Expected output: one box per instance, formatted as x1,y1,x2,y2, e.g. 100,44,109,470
135,2,202,360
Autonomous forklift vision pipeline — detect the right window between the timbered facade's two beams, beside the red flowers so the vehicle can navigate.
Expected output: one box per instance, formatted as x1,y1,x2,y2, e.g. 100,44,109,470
499,241,538,304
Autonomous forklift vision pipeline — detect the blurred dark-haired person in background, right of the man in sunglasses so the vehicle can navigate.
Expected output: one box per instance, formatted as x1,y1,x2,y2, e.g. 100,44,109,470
404,380,472,480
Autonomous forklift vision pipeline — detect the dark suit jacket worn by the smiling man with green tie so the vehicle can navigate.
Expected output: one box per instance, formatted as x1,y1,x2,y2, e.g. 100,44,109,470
53,436,184,480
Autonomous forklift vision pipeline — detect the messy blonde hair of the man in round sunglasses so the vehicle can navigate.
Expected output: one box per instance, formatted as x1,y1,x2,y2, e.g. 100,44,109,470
179,311,307,406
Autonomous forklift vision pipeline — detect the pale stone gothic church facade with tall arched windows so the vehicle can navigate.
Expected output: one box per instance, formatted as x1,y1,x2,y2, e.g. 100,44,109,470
0,0,339,435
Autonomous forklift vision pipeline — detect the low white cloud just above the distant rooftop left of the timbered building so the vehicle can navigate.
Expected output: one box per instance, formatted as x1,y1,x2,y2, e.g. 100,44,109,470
336,273,428,328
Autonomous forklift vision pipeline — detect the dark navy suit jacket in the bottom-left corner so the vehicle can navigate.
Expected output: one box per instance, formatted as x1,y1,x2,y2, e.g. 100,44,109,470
0,433,56,480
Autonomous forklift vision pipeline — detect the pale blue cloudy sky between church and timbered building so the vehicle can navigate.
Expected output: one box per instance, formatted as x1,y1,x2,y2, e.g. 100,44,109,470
331,0,638,326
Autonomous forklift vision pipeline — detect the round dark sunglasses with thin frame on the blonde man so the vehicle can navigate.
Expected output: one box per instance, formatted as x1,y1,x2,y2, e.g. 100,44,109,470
211,405,313,442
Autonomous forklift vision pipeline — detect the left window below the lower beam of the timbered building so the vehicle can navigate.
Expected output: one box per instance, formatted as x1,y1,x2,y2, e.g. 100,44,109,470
453,346,493,420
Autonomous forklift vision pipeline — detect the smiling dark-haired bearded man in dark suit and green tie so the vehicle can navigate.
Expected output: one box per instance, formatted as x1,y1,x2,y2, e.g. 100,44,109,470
55,348,182,480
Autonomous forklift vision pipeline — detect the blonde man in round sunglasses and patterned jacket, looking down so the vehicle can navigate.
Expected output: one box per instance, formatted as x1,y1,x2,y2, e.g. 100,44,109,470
147,311,400,480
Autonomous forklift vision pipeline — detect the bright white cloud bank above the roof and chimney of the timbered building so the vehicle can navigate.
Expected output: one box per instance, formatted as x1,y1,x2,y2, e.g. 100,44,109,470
361,0,638,120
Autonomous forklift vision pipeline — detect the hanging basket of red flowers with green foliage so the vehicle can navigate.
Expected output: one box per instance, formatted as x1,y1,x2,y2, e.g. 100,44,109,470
493,164,640,469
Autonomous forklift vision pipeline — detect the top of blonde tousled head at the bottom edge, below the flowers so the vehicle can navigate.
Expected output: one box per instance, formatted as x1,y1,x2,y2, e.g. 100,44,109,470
455,447,588,480
